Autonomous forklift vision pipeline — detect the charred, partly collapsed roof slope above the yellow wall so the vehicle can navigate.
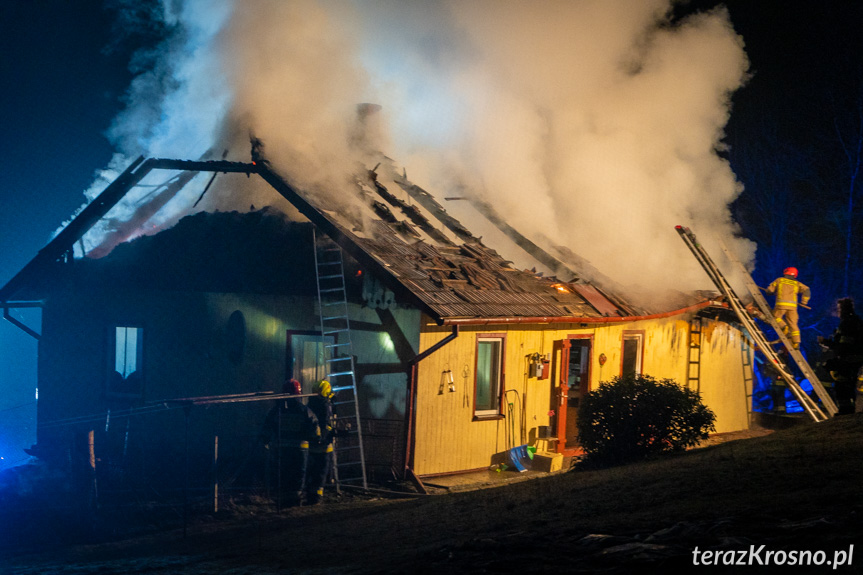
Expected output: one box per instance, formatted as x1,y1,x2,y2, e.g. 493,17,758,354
312,158,638,321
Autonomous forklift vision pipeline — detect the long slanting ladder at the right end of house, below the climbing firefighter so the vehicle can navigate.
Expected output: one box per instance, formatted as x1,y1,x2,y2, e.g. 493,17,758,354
675,226,837,422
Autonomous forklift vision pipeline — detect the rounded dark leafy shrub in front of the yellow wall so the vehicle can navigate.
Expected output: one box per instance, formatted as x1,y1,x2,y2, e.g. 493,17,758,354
578,375,716,463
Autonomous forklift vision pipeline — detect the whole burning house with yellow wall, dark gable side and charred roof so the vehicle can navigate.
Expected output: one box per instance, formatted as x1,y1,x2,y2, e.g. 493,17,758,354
0,151,752,498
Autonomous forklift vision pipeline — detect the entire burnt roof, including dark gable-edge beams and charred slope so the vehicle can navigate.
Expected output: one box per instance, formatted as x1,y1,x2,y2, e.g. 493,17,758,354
0,150,708,323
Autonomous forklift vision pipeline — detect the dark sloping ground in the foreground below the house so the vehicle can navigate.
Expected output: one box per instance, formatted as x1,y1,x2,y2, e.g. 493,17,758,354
0,414,863,575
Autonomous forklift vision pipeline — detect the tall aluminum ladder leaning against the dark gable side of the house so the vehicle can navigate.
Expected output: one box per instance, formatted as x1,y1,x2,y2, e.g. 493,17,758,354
312,231,368,491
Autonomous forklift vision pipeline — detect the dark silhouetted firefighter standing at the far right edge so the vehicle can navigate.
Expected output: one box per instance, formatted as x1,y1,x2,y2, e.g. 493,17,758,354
818,298,863,415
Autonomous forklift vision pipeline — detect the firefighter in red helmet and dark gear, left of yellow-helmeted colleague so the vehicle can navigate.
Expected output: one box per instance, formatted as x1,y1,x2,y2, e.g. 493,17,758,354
263,379,321,505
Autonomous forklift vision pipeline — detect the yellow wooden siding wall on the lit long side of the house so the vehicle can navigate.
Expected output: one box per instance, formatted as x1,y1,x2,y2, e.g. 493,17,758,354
414,315,748,475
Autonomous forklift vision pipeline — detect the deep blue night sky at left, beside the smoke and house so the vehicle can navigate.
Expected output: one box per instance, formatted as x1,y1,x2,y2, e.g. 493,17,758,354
0,0,131,468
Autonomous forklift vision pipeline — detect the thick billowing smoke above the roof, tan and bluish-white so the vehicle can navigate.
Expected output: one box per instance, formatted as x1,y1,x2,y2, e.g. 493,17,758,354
74,0,752,304
